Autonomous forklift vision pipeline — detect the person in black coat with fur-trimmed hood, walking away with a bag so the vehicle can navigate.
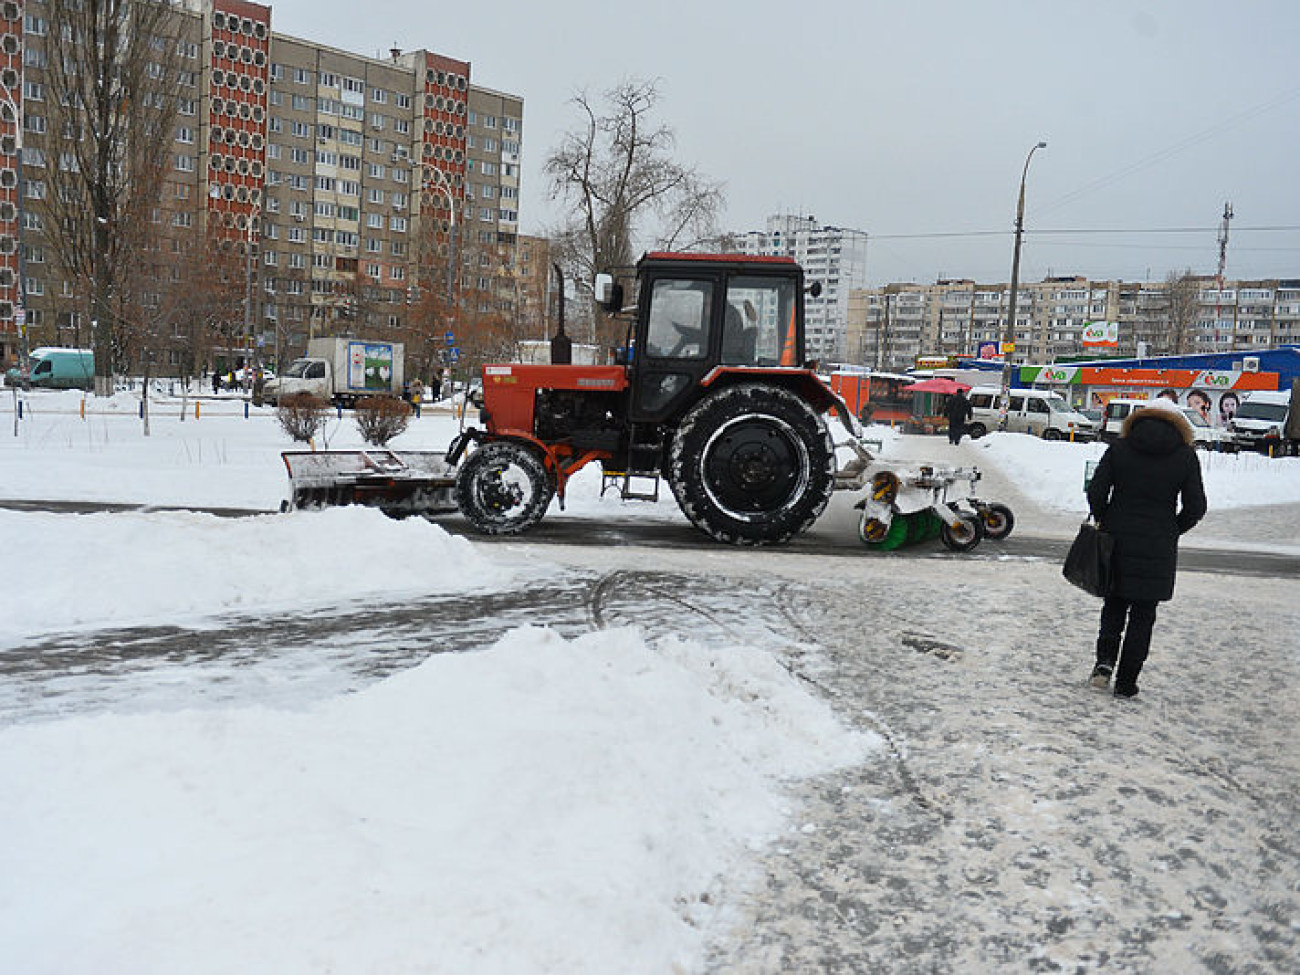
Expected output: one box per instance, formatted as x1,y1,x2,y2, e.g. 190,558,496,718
1088,400,1205,697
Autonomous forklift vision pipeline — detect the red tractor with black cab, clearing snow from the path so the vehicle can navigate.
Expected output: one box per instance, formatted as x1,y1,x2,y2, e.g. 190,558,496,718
447,254,870,545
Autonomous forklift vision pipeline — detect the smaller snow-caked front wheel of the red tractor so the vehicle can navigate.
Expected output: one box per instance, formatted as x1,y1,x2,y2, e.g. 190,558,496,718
456,441,555,534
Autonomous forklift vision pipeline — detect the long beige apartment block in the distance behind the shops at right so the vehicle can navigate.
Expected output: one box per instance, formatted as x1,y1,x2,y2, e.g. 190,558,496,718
842,276,1300,369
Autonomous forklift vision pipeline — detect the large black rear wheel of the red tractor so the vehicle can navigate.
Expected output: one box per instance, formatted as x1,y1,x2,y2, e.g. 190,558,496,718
668,384,835,545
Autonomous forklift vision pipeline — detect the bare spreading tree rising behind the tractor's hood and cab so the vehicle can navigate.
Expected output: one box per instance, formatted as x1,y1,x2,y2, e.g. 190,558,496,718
545,79,723,351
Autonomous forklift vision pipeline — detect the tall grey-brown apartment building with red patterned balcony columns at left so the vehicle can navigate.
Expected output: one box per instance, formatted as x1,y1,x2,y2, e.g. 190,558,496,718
0,0,524,374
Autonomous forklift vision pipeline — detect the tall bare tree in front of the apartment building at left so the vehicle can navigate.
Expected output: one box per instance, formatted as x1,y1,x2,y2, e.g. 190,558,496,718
40,0,186,395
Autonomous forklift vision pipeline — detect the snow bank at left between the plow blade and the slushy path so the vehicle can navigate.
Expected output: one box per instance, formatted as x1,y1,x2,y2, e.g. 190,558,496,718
0,507,512,645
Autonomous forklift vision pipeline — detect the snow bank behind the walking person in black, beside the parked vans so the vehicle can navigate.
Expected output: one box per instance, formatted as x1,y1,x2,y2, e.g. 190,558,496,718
967,433,1300,512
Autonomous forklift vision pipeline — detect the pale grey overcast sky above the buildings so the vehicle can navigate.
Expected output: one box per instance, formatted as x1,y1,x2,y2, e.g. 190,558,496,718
272,0,1300,285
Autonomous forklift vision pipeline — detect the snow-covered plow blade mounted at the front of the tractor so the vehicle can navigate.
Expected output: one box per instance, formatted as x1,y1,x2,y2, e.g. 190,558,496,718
280,449,456,517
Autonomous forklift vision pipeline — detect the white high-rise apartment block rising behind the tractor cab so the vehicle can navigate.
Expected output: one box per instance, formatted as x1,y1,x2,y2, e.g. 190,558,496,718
724,215,867,360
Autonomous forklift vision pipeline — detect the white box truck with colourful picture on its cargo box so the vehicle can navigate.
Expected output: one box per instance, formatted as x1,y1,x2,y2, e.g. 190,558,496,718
263,338,406,407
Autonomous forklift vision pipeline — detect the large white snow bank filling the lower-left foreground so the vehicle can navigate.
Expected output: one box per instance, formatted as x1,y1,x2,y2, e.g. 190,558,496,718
0,626,879,975
